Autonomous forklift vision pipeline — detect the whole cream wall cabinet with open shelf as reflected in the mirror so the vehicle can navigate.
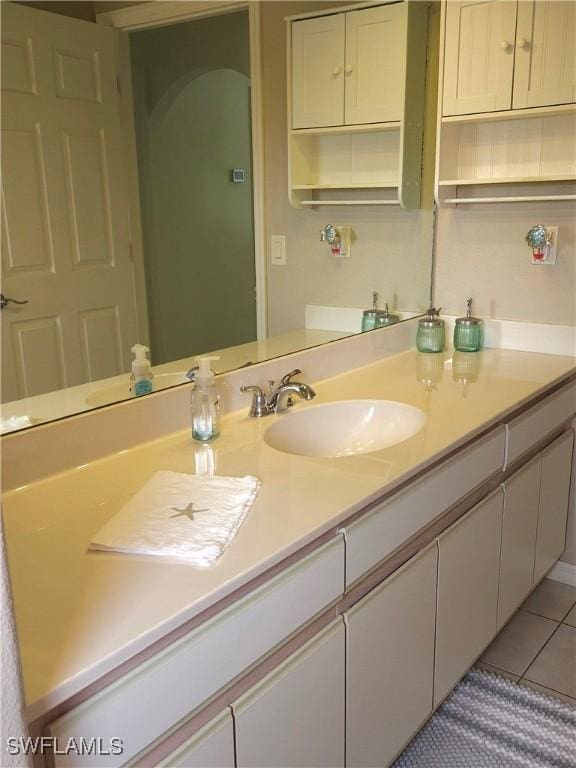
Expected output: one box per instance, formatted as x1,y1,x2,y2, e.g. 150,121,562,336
288,0,429,208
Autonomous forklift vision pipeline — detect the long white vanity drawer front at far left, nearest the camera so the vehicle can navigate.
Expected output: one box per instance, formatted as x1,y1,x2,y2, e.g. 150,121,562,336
49,536,344,768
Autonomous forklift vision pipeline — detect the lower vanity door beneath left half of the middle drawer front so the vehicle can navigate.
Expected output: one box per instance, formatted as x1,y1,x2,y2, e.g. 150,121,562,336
346,542,438,768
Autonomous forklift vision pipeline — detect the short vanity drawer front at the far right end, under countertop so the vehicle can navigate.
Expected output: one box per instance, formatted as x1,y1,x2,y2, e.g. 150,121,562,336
506,381,576,466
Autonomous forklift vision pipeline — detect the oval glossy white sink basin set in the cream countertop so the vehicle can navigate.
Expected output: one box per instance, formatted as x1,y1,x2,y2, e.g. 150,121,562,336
264,400,426,458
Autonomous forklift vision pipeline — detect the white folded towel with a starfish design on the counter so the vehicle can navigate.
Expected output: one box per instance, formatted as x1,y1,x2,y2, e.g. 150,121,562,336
88,471,260,568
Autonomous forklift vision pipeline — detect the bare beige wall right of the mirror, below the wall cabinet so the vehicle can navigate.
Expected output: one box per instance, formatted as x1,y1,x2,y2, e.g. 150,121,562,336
434,202,576,325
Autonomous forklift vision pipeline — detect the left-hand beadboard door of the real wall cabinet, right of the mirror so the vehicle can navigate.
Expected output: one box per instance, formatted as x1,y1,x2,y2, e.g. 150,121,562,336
443,0,516,115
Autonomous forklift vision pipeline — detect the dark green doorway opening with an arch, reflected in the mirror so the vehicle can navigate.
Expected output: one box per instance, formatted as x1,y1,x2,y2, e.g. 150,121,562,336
130,12,256,364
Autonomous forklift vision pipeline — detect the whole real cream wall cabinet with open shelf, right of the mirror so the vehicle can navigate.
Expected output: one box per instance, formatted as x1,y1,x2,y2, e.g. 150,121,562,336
436,0,576,204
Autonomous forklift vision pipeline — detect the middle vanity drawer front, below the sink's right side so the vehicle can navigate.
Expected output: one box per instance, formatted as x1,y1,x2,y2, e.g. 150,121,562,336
344,427,506,586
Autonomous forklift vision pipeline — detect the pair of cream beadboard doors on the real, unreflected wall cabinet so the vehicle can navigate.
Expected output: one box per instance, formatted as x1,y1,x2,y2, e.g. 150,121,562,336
443,0,576,115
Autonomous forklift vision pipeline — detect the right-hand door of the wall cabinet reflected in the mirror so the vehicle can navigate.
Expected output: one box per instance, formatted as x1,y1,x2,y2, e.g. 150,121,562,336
345,3,408,125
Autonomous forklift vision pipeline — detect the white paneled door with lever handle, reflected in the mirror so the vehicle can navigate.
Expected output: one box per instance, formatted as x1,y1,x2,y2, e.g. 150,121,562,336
1,3,137,401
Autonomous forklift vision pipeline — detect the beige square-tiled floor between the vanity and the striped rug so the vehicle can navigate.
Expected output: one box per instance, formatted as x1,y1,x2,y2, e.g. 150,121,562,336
477,579,576,707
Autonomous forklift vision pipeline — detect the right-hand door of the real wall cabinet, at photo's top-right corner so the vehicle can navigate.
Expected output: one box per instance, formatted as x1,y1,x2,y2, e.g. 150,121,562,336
512,0,576,109
